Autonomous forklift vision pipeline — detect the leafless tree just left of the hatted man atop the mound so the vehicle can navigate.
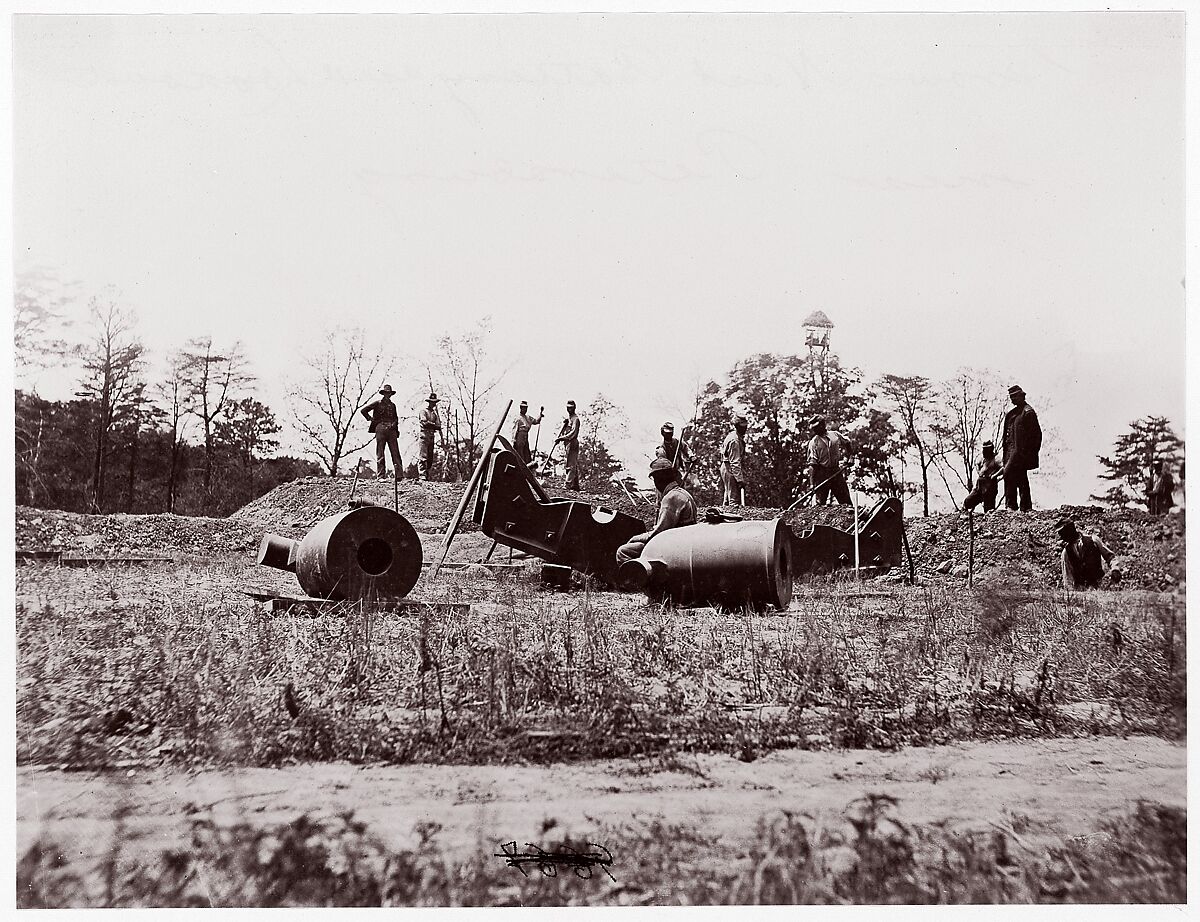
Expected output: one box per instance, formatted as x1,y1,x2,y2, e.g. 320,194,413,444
288,328,391,477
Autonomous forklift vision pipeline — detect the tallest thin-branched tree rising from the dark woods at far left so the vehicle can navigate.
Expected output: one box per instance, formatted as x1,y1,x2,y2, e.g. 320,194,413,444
79,294,145,513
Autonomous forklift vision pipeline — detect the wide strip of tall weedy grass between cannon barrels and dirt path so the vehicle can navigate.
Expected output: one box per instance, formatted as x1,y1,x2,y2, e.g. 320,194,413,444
17,568,1186,767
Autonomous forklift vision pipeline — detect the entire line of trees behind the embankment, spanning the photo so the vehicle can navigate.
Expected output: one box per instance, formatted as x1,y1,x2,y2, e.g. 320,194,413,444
14,264,1183,515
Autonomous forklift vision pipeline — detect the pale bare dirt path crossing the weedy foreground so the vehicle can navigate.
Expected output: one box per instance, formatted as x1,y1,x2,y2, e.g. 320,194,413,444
17,737,1187,864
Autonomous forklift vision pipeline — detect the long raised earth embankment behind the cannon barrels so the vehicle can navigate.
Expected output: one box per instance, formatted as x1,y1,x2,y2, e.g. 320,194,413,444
17,477,1186,591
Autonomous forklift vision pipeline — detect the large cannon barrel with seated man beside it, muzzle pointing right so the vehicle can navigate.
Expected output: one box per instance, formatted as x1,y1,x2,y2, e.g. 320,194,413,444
617,519,792,610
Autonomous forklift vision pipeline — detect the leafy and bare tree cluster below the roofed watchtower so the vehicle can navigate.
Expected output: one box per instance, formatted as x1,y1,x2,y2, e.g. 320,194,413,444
690,351,1008,515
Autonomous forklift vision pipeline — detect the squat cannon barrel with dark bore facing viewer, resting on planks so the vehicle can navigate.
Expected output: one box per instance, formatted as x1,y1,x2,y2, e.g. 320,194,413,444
258,505,421,600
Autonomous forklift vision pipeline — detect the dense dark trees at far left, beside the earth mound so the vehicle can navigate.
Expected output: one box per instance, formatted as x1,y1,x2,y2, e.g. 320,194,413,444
14,270,319,515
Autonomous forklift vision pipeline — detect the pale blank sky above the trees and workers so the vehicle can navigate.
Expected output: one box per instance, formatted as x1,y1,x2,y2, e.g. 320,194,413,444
13,13,1184,505
